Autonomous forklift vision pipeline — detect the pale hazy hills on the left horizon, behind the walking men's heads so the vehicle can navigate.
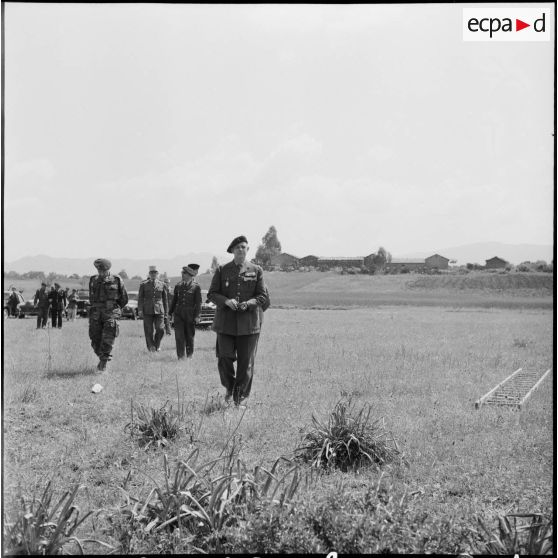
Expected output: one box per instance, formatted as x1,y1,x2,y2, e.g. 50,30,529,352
4,252,230,277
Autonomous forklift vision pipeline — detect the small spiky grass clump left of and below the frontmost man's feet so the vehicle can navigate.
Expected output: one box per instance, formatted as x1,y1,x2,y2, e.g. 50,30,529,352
126,401,189,449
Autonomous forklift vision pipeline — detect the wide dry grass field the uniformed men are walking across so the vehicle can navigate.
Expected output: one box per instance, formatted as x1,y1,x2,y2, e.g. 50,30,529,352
3,273,554,553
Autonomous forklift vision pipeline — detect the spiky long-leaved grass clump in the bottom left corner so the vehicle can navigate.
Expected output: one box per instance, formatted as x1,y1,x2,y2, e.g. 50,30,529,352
2,481,112,555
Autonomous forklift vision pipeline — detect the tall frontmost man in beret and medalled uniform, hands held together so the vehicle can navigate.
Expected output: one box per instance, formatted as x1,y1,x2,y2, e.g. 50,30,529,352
207,236,267,405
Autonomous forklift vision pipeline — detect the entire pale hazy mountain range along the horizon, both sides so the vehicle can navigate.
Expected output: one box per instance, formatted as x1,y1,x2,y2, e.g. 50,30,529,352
4,242,554,277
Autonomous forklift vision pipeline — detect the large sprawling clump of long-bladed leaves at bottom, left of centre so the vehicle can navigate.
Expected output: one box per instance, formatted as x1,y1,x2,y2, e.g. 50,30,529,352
111,443,300,552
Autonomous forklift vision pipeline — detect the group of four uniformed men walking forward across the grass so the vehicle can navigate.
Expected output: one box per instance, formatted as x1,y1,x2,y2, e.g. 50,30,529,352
89,236,269,405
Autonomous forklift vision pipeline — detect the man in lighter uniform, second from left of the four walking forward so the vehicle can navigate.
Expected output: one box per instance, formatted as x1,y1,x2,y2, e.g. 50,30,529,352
138,265,169,351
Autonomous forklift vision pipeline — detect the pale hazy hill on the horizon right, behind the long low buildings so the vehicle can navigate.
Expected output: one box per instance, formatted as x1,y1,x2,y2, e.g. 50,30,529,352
400,242,554,265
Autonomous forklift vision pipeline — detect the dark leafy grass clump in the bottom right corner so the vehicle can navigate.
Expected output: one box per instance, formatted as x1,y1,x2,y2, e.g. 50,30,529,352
473,513,554,556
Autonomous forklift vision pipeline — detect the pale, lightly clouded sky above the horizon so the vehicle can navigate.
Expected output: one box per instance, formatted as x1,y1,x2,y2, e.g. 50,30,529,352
3,2,555,262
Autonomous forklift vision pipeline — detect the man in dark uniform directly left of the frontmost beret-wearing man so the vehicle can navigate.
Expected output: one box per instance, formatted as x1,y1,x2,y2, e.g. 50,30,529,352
169,264,205,360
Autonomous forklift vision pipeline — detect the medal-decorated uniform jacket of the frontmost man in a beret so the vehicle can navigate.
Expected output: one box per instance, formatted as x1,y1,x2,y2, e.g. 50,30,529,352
207,260,266,335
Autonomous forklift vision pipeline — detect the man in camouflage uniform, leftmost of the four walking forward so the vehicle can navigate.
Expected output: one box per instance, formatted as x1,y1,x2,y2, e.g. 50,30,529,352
89,258,128,372
